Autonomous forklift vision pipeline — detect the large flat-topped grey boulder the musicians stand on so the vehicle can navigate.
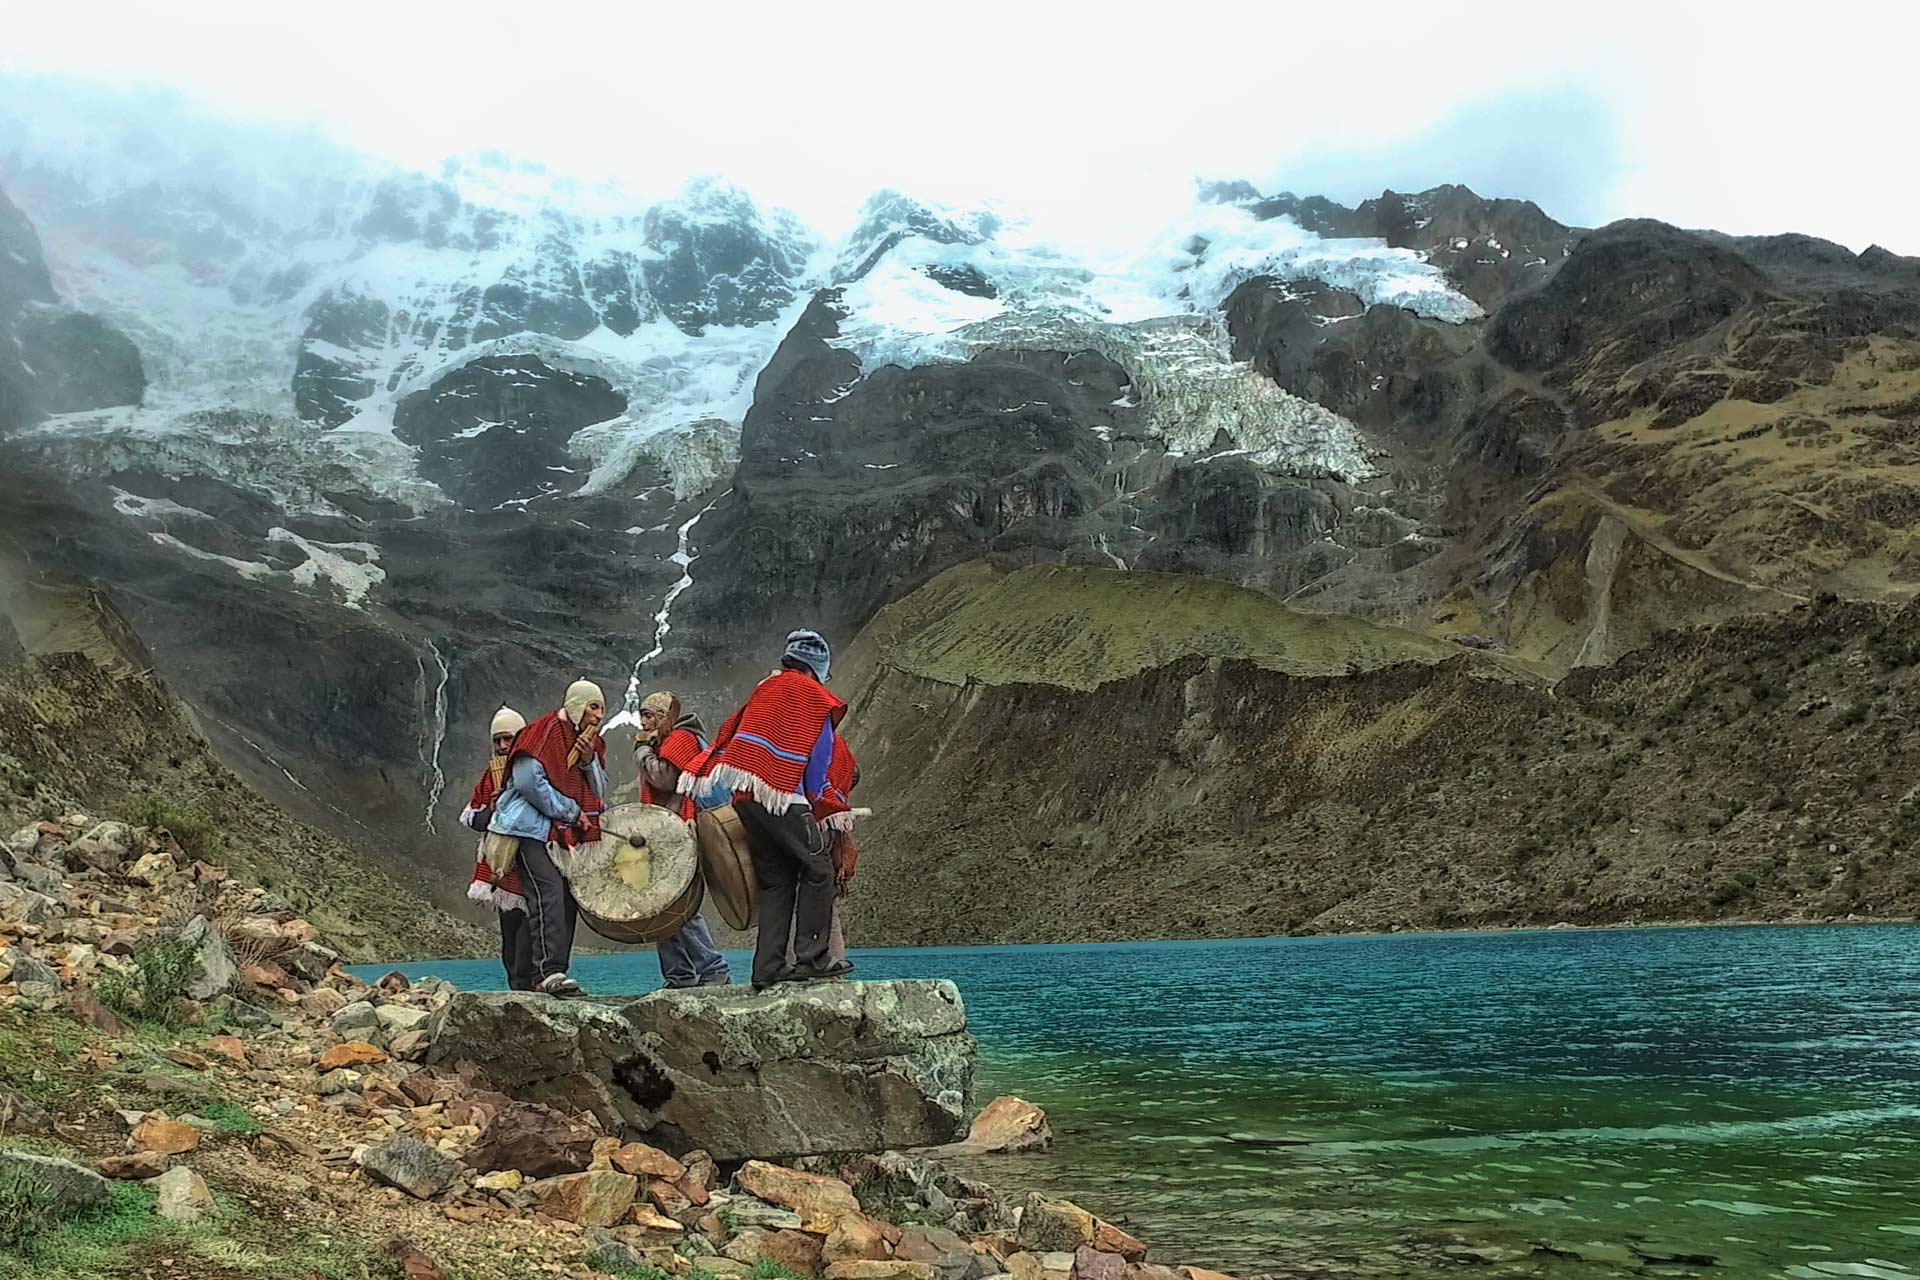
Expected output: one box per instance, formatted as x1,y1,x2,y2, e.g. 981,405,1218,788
426,981,977,1161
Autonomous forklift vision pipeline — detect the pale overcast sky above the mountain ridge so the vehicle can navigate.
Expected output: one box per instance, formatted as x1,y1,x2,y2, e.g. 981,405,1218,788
0,0,1920,253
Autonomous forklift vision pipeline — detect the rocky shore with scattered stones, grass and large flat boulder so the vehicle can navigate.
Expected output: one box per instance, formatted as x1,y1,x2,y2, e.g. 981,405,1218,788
0,814,1259,1280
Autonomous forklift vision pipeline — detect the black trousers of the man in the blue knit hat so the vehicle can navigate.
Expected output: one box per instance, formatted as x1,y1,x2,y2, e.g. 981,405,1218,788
733,800,833,986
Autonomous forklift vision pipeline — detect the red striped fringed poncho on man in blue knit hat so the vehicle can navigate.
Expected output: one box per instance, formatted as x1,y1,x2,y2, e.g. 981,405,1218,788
680,668,847,814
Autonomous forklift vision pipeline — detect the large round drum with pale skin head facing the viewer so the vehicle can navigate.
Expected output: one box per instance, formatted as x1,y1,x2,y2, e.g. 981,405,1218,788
566,804,707,942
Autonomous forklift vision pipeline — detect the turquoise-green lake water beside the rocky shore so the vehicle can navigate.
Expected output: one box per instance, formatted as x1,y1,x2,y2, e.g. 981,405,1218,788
361,927,1920,1280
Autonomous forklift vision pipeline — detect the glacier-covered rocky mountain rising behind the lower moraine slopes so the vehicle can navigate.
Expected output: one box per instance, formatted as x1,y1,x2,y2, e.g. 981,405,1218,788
0,92,1920,936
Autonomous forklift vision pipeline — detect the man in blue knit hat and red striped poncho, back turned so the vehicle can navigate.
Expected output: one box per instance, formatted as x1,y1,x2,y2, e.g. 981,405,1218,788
680,631,851,990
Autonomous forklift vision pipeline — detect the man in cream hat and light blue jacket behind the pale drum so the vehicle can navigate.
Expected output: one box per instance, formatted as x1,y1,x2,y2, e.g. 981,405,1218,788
482,679,607,996
